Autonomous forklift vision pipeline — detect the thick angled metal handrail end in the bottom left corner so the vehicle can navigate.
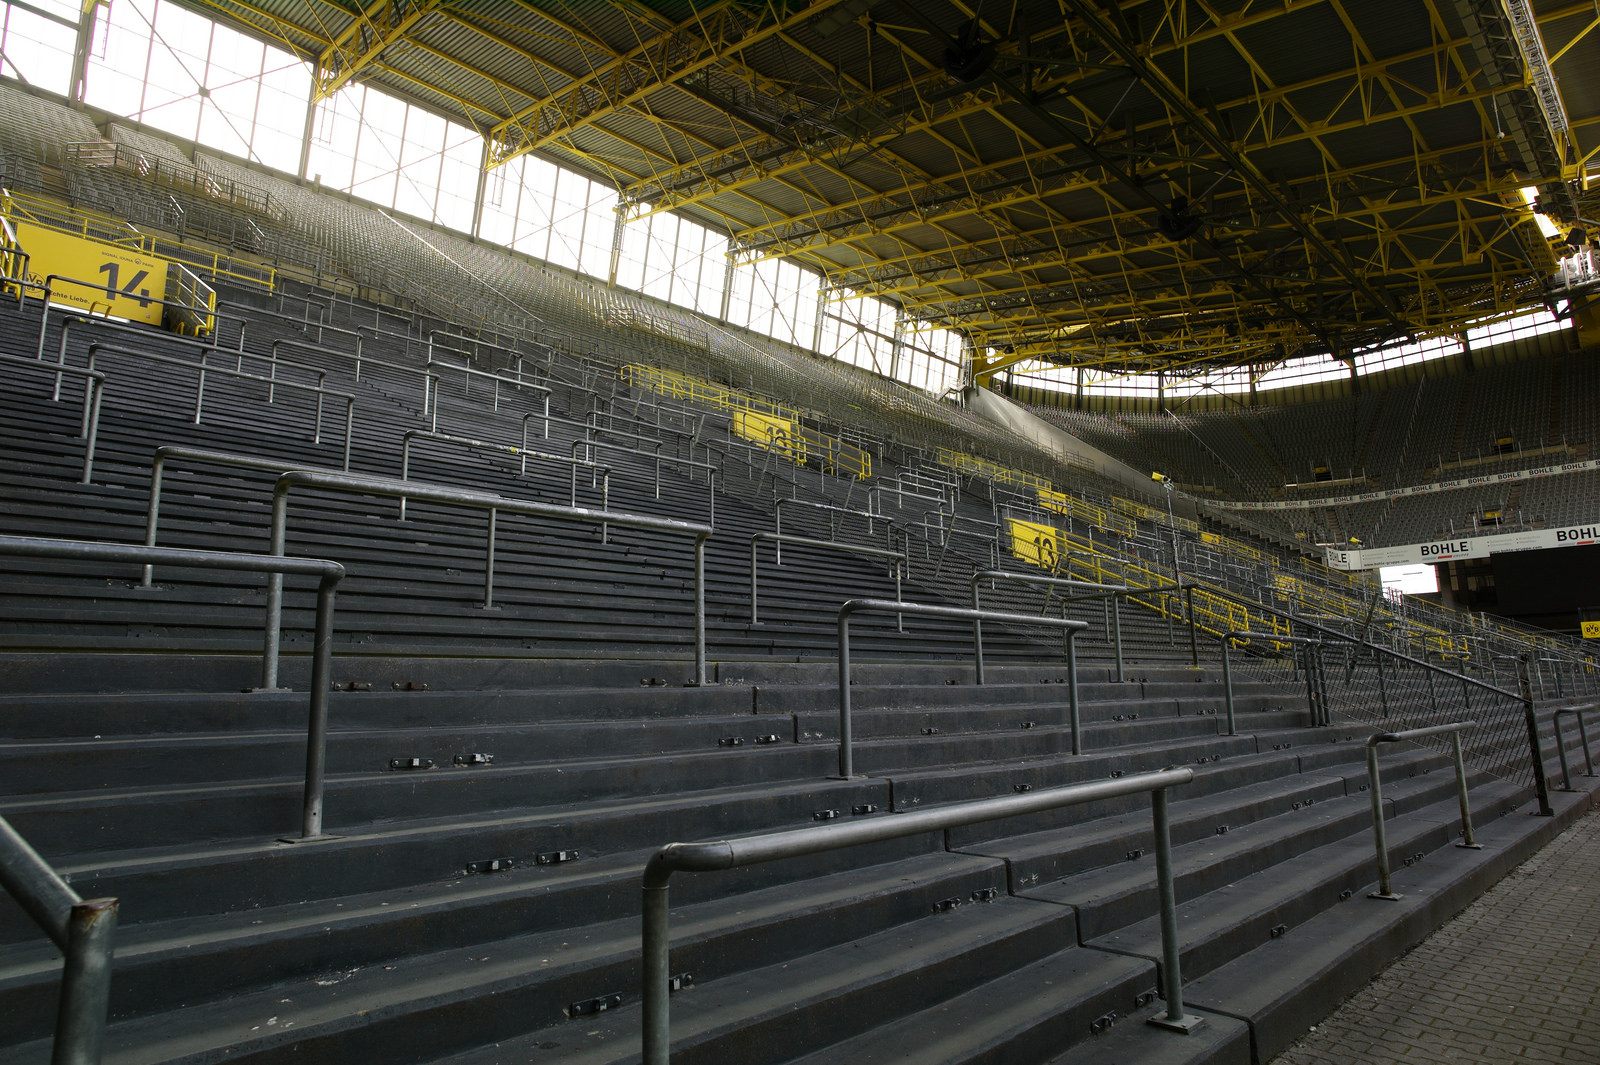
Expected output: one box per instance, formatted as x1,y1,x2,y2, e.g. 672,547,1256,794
0,817,118,1065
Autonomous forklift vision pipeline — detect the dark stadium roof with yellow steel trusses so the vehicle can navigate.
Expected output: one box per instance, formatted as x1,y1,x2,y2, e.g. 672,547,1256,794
189,0,1600,371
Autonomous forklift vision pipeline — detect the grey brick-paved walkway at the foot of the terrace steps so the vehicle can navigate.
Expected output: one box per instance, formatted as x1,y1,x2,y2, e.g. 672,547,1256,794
1272,799,1600,1065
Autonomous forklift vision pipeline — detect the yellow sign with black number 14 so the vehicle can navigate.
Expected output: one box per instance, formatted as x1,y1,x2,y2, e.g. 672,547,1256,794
14,221,168,325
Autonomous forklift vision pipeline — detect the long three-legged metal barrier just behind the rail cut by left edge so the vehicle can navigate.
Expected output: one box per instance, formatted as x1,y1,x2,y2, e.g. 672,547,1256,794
267,470,712,686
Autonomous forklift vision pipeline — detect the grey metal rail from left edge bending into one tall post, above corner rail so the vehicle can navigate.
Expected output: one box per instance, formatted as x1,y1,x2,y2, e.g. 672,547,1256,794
0,536,344,840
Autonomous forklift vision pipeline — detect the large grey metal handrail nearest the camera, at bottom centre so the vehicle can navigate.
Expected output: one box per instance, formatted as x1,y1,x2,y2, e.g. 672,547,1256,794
642,768,1205,1065
